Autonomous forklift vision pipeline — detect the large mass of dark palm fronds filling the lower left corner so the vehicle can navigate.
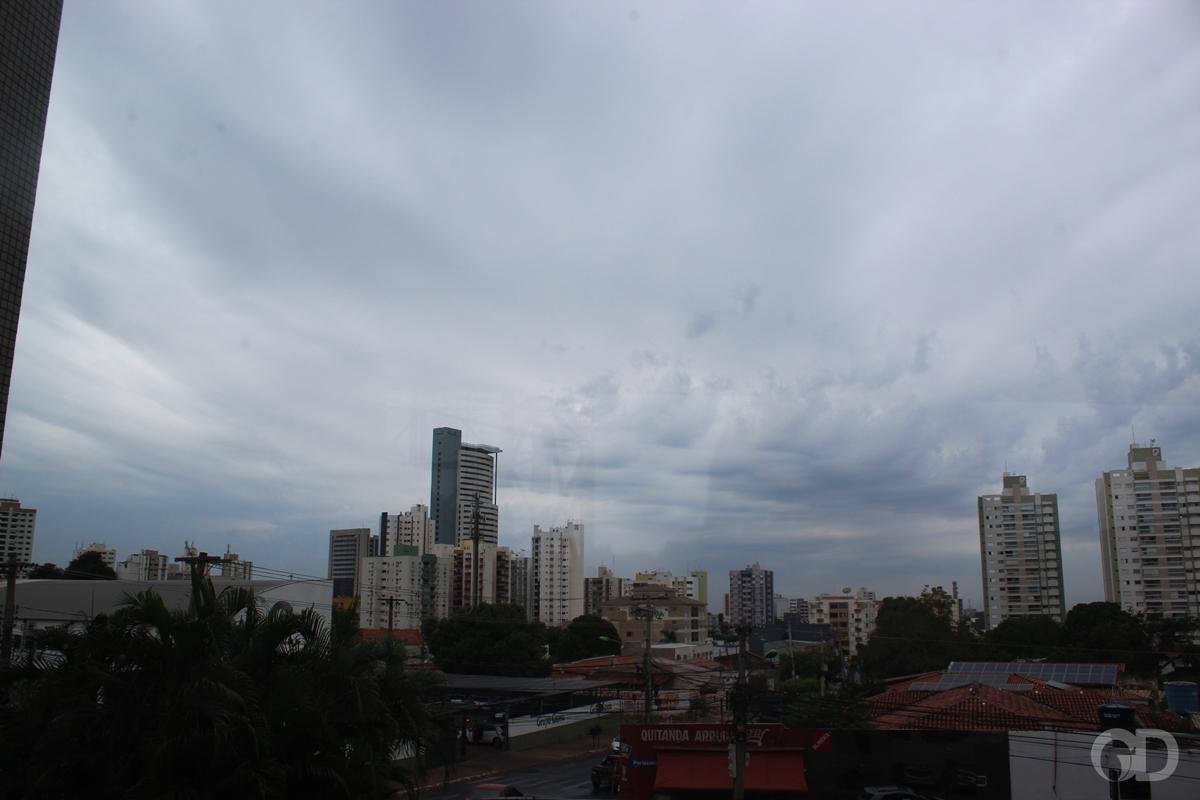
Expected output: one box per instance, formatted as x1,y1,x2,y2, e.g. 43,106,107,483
0,576,433,800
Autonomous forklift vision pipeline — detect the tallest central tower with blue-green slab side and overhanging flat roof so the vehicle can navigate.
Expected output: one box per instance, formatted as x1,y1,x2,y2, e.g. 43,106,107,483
430,428,502,545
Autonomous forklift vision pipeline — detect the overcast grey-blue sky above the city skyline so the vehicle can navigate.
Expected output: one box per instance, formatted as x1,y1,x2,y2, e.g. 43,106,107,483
0,2,1200,606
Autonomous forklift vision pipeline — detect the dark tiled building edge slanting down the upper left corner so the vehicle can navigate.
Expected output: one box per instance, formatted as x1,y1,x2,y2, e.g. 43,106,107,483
0,0,62,455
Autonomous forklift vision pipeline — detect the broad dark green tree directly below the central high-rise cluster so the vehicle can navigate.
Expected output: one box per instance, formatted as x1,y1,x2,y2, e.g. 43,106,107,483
425,603,550,676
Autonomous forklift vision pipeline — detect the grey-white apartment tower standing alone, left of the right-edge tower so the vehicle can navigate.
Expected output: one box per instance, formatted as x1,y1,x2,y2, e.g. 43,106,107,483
977,473,1067,628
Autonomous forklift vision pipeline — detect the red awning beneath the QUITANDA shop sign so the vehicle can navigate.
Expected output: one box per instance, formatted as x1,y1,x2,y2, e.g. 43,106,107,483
654,750,809,792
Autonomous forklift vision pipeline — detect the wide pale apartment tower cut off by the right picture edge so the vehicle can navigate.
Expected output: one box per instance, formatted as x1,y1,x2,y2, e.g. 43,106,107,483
1096,439,1200,616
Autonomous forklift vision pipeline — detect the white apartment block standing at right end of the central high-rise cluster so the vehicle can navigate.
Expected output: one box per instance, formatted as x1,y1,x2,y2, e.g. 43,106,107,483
529,522,583,625
